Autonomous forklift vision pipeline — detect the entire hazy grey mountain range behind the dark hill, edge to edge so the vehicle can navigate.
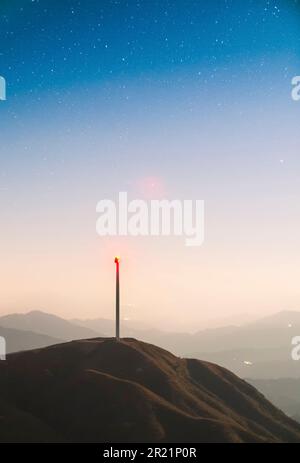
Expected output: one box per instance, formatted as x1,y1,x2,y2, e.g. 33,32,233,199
0,311,300,379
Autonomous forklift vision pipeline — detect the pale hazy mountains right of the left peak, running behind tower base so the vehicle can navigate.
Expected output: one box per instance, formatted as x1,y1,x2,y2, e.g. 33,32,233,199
69,311,300,378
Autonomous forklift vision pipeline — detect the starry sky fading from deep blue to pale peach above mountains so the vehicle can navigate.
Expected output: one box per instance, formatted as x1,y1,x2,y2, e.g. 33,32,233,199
0,0,300,330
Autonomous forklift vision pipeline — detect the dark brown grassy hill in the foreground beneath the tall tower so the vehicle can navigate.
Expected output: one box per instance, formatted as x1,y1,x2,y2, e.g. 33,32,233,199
0,338,300,442
